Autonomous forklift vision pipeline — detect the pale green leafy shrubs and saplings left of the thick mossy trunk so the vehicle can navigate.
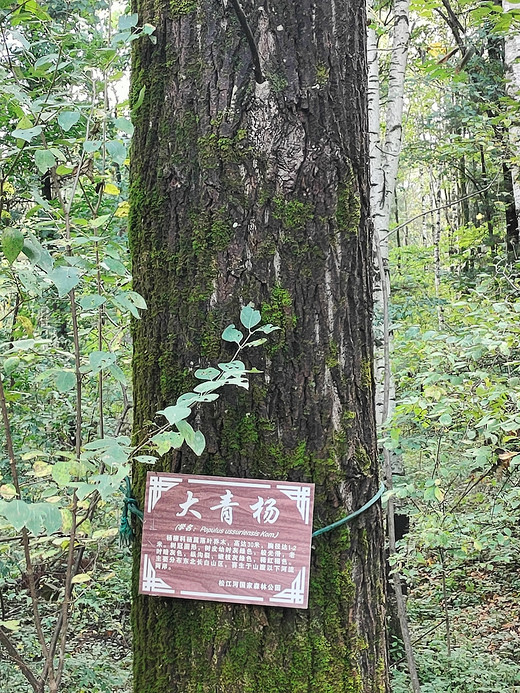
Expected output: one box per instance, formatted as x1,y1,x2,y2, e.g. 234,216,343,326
0,1,155,693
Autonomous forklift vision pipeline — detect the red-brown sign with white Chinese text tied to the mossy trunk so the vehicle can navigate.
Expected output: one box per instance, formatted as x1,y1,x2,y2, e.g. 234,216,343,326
139,472,314,609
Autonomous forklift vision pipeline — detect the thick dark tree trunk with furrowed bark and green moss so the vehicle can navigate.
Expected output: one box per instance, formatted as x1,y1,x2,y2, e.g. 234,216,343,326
130,0,386,693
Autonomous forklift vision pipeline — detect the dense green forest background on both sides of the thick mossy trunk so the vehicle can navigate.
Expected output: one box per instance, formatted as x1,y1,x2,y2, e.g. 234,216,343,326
0,0,520,693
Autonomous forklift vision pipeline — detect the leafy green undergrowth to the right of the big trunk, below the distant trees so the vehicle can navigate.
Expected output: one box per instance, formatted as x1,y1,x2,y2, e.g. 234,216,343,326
384,246,520,693
